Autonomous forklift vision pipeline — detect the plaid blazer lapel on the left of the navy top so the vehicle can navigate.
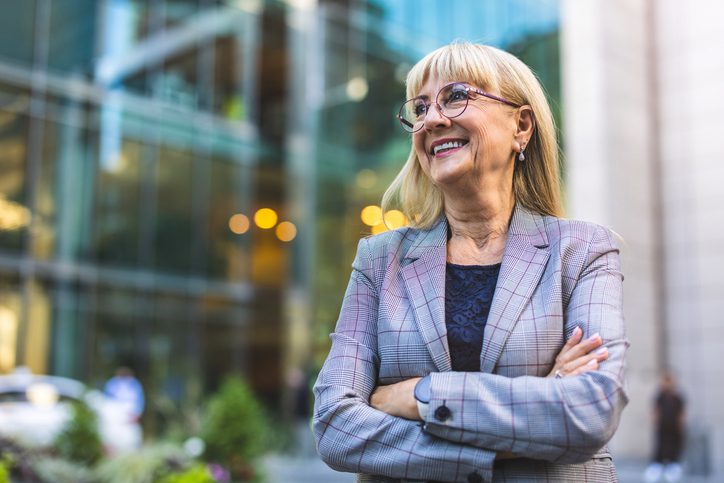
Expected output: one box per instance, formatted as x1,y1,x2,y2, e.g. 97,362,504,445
400,217,452,372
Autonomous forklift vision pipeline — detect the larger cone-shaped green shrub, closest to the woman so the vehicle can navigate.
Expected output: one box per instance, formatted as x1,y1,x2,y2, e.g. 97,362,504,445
201,377,270,481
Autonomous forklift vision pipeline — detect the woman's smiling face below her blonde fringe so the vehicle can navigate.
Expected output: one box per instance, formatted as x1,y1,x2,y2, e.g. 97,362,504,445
412,76,519,190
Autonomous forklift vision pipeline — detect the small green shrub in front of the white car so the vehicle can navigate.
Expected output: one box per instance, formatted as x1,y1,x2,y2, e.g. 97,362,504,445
53,402,103,465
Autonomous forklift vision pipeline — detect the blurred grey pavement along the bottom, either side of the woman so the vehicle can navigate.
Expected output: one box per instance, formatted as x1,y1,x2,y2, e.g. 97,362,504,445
264,453,724,483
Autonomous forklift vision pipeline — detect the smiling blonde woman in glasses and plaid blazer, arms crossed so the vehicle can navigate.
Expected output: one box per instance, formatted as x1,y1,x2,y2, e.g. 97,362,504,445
314,43,628,482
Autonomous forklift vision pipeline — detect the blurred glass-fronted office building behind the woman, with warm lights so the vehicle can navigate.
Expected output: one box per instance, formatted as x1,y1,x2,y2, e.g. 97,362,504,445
0,0,559,431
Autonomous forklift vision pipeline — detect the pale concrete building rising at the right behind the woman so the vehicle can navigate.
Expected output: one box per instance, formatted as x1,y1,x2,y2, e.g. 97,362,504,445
561,0,724,481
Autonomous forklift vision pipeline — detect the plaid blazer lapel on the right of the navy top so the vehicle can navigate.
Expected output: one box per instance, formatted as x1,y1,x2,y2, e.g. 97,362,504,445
480,205,550,372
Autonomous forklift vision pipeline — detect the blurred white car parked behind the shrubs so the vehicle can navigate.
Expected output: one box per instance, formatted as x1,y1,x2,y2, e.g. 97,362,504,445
0,368,142,454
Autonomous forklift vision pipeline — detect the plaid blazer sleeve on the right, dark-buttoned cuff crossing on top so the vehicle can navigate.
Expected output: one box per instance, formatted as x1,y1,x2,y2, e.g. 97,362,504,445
425,227,628,463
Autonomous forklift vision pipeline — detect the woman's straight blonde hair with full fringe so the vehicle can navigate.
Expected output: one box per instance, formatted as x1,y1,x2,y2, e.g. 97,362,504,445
382,42,563,228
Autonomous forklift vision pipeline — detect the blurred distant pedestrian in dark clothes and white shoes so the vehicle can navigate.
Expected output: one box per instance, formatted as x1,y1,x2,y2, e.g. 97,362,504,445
644,372,686,482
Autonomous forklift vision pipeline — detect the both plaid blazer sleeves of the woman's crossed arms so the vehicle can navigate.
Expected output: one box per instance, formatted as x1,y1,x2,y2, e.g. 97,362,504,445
314,228,627,481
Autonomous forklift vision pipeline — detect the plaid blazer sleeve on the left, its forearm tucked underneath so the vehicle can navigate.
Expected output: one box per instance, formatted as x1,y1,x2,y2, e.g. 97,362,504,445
313,239,495,481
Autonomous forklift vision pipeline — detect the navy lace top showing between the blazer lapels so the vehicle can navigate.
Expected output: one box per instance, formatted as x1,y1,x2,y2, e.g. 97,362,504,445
445,263,500,371
